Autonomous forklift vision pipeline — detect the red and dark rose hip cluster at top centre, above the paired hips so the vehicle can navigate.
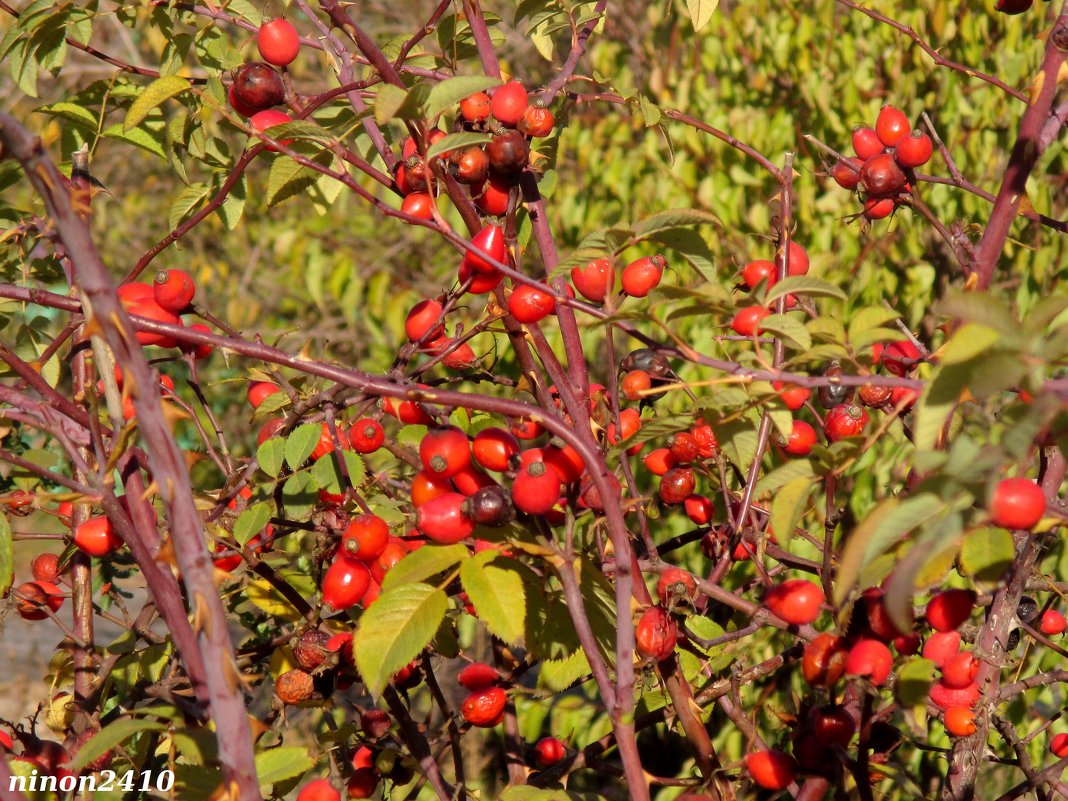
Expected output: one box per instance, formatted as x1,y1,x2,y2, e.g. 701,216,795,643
394,80,555,224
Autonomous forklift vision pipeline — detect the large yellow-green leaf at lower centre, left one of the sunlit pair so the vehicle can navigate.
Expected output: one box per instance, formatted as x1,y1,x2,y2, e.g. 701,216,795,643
352,583,449,695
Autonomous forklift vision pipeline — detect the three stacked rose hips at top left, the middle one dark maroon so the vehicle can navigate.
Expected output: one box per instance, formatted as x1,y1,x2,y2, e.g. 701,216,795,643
227,18,300,142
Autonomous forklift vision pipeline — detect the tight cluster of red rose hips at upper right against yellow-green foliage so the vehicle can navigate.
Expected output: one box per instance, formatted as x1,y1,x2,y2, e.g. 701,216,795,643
831,106,933,220
